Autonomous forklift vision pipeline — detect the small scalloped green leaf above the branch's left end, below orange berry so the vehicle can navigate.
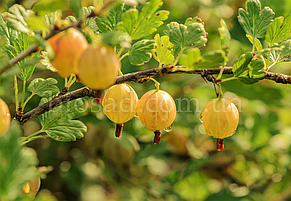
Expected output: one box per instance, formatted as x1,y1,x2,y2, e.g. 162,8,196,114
27,78,60,98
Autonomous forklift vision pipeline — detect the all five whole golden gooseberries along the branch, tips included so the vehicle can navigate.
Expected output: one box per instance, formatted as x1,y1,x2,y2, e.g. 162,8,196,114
48,28,239,146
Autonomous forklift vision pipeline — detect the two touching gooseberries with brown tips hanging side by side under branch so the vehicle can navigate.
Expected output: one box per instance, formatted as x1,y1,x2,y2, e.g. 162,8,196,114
102,81,176,144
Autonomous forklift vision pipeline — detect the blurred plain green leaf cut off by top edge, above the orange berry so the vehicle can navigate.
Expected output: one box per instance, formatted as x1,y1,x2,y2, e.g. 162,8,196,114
32,0,67,16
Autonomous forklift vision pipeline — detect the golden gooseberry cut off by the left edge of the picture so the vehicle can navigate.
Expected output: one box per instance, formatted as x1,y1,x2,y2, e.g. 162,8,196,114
0,98,11,137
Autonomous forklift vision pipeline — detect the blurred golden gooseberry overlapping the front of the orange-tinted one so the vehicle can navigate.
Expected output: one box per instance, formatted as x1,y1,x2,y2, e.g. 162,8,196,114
76,46,119,90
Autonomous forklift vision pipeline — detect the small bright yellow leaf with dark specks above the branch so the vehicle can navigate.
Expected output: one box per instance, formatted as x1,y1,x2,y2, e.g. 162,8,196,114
152,34,174,65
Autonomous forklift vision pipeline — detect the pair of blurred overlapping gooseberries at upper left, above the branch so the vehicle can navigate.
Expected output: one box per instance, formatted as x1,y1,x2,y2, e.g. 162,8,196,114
48,28,119,90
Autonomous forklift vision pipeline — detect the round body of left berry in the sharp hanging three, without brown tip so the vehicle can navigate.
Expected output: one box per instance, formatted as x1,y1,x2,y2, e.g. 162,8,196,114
102,84,138,124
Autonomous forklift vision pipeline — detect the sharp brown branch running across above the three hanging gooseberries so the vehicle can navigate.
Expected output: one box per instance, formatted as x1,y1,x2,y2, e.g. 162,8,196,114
17,66,291,124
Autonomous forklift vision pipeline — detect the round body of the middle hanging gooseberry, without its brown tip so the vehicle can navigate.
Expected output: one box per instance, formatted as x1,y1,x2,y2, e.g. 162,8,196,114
137,90,176,131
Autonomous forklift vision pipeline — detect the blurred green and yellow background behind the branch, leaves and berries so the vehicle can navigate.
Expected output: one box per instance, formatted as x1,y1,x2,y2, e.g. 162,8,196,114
0,0,291,201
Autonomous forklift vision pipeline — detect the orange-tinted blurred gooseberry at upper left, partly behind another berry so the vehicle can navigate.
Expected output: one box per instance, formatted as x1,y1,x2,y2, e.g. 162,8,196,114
48,28,88,78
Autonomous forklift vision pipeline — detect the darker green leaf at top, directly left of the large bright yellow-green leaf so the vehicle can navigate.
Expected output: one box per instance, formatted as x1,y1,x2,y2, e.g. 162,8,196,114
95,3,130,33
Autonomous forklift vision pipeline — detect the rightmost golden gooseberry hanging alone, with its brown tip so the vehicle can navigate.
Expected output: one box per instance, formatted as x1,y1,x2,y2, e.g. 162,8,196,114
201,98,239,151
